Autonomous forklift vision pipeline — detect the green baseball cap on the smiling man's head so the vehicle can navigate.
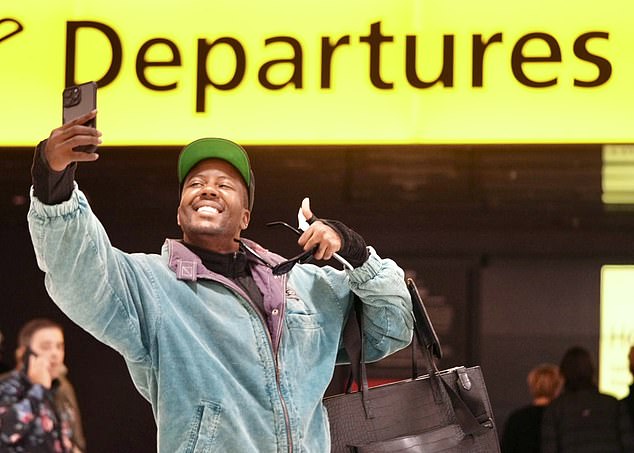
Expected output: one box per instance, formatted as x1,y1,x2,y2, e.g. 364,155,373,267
178,138,255,211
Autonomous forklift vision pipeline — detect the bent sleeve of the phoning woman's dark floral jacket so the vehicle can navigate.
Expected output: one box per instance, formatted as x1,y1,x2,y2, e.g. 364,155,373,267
0,378,46,444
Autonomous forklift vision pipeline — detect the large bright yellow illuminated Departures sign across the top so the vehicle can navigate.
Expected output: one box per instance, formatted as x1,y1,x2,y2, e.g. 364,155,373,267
0,0,634,146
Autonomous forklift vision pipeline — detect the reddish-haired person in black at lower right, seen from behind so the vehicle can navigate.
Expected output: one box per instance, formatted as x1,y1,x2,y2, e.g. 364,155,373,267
502,363,562,453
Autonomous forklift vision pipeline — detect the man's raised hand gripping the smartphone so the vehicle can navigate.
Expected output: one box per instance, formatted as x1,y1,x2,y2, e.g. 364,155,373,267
44,110,101,171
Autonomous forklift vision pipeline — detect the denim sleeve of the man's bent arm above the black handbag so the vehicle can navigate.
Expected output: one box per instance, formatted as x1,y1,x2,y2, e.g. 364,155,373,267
346,247,414,362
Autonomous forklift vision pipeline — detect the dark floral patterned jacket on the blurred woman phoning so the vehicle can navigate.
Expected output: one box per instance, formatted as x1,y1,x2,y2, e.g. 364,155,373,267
0,371,73,453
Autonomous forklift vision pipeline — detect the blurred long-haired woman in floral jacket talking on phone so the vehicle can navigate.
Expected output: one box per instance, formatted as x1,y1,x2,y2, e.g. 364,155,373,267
0,318,86,453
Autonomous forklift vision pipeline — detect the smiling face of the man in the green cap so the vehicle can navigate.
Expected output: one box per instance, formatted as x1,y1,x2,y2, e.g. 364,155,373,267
177,159,250,253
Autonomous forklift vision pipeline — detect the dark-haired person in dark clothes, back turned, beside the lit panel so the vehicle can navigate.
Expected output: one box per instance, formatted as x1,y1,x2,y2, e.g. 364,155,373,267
542,346,634,453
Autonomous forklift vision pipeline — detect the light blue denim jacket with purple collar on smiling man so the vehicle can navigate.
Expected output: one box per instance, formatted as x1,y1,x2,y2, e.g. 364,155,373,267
28,187,413,453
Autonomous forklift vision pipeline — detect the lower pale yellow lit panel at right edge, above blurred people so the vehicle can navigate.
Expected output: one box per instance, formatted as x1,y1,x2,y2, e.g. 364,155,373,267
599,266,634,398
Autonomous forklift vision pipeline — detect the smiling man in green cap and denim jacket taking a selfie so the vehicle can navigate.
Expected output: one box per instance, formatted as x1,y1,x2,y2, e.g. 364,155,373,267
28,112,413,453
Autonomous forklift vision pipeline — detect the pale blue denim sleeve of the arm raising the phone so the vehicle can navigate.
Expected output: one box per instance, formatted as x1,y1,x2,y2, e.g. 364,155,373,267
28,185,156,365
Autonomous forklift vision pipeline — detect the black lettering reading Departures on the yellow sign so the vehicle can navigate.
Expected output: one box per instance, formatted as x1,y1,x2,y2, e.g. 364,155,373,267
61,18,612,113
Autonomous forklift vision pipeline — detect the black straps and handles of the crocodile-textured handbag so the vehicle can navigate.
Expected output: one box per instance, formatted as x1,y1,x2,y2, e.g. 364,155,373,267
343,279,488,434
